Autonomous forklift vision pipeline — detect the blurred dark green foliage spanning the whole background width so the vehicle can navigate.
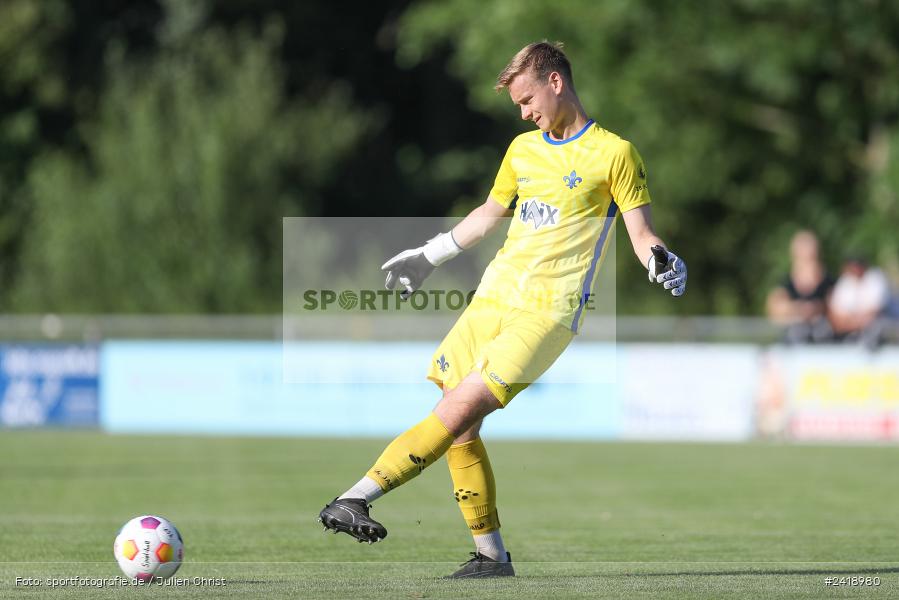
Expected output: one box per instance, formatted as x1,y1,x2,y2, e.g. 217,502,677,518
0,0,899,314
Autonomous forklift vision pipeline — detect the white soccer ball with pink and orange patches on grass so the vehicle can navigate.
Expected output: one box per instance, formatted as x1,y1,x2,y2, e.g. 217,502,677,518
112,515,184,581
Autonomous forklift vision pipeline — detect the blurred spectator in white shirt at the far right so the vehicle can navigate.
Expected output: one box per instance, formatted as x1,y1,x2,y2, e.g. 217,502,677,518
828,256,890,349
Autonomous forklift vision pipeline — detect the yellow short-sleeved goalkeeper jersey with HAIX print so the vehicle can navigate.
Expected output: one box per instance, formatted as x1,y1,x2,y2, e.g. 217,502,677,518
475,120,650,333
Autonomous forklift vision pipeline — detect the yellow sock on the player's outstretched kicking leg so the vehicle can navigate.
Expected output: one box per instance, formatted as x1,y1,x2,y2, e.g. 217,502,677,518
366,413,454,492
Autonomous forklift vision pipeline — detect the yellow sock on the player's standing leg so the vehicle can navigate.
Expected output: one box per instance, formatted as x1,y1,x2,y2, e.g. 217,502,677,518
446,438,499,535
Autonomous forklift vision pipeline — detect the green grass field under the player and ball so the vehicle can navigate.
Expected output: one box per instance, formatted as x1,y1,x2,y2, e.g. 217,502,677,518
0,431,899,600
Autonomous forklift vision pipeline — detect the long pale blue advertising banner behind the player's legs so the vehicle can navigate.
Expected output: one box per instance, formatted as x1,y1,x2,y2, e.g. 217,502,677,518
101,341,620,439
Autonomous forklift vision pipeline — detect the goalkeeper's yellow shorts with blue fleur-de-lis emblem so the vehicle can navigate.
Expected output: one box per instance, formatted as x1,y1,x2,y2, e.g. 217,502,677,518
428,297,574,406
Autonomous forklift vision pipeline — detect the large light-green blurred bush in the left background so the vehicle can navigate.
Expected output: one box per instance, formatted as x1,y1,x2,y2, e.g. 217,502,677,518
14,0,367,312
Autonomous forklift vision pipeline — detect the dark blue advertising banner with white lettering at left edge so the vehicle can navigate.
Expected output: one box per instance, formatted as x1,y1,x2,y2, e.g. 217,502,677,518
0,344,100,427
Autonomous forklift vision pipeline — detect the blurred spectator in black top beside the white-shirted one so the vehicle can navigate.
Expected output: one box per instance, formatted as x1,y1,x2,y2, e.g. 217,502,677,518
766,230,833,344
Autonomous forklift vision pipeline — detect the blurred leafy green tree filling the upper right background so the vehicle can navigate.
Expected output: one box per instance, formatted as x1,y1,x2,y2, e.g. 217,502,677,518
398,0,899,313
